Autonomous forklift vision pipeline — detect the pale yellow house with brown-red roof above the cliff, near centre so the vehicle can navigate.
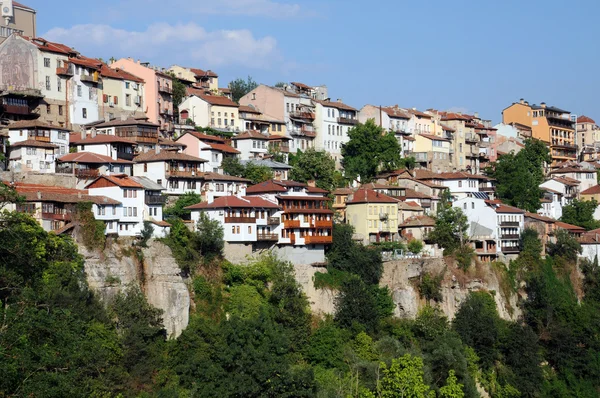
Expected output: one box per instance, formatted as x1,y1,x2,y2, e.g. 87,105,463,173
346,189,399,244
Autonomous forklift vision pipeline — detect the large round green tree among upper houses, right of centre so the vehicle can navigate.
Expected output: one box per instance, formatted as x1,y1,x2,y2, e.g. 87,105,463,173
342,119,401,183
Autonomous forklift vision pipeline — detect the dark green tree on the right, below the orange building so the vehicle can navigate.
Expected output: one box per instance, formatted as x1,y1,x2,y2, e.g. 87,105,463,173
487,139,552,213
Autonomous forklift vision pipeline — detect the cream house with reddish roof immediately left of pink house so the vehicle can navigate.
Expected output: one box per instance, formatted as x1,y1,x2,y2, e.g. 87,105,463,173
98,63,146,120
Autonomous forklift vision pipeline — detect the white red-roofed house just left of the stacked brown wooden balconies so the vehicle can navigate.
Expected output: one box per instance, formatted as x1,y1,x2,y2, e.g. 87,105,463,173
186,195,281,262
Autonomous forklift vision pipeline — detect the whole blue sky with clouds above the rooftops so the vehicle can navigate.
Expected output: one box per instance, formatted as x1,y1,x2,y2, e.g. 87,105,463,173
25,0,600,123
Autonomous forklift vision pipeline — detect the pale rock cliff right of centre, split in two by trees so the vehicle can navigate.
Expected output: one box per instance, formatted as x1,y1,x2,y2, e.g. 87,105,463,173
304,258,521,320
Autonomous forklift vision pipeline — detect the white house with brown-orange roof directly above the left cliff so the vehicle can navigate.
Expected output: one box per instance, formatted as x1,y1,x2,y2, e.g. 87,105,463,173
86,174,145,236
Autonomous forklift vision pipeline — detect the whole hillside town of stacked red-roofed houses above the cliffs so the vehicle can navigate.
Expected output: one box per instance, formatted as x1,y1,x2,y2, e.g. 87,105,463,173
0,2,600,264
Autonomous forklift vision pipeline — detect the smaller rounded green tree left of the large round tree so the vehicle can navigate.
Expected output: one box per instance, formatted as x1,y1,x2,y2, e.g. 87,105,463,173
290,148,335,192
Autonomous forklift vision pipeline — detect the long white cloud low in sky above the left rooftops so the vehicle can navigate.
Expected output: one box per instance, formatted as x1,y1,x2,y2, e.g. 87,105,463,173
42,23,281,69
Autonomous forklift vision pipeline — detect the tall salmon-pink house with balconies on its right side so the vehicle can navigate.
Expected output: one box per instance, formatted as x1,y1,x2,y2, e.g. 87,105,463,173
110,58,173,133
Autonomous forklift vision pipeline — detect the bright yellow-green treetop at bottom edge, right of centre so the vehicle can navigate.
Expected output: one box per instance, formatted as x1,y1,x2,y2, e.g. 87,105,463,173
377,354,435,398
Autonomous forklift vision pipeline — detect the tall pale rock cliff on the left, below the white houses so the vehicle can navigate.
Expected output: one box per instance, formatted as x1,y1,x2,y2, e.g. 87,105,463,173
79,239,190,338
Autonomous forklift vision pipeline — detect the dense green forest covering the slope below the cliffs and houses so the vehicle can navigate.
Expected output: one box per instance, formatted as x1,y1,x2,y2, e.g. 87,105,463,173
0,199,600,398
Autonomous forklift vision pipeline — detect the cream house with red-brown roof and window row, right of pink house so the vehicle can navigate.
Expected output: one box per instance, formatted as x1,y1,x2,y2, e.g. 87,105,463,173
179,88,240,131
